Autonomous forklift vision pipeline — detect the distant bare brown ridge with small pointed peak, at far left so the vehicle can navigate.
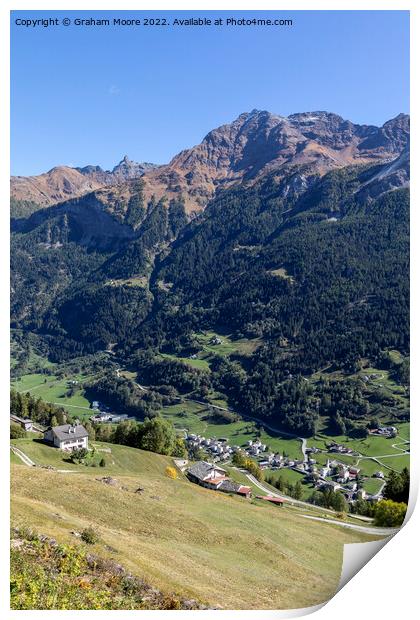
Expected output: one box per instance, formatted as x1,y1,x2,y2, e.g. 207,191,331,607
10,156,155,206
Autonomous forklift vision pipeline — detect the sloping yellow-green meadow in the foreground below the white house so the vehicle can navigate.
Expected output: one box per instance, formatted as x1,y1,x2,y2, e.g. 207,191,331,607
11,440,388,609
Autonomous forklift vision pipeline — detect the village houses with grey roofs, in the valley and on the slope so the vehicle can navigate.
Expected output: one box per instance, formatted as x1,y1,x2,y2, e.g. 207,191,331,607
11,392,398,504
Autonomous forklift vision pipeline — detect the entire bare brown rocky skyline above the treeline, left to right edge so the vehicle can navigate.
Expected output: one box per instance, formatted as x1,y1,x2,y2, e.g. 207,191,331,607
11,110,409,213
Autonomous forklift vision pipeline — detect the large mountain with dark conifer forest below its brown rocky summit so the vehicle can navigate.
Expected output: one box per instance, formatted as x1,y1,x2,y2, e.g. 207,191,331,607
11,111,409,433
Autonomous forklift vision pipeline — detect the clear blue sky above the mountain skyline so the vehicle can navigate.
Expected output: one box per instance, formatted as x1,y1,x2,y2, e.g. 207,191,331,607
11,11,409,175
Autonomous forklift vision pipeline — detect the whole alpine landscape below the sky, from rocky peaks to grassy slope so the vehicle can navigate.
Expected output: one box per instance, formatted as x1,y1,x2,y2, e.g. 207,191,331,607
11,110,410,609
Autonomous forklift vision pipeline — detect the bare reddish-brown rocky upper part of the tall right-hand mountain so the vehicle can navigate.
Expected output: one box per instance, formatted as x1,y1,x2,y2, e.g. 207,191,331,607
139,110,409,211
